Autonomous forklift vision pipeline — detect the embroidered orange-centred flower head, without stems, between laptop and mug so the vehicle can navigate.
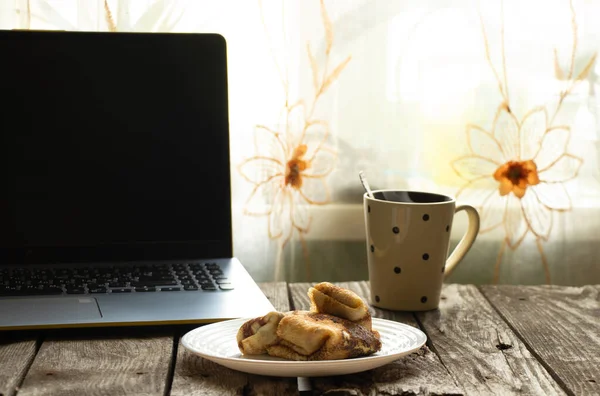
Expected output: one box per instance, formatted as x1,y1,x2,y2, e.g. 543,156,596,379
238,102,337,246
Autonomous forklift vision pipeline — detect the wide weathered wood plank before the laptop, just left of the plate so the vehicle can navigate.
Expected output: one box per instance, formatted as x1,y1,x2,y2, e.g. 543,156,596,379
18,329,173,396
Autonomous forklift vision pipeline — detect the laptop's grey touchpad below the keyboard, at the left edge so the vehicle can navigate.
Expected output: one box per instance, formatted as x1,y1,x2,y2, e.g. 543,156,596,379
0,296,102,327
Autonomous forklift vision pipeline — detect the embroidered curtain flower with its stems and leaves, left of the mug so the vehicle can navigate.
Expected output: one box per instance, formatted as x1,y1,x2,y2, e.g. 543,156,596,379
239,0,350,280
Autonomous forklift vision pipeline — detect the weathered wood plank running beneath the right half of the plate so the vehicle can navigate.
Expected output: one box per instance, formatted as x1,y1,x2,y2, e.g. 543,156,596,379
290,282,463,395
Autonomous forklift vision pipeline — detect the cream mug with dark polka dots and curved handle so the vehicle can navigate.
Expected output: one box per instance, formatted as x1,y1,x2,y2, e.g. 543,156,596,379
363,190,479,311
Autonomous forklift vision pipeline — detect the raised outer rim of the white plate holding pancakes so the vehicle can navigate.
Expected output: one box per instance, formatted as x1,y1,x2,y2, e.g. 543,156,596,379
181,318,428,371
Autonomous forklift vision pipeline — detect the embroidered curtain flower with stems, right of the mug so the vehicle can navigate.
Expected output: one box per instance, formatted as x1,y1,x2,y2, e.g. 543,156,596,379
451,2,596,283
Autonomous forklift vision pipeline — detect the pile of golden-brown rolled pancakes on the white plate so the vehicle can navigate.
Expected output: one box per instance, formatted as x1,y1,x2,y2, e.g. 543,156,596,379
237,282,381,360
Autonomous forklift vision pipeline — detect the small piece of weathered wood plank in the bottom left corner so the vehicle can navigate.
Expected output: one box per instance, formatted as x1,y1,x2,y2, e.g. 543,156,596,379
0,332,36,396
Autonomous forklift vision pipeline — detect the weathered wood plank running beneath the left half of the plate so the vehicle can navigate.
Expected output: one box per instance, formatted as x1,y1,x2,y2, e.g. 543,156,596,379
171,282,298,396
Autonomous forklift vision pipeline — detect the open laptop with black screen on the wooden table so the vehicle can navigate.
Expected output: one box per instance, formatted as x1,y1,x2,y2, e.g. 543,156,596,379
0,31,273,330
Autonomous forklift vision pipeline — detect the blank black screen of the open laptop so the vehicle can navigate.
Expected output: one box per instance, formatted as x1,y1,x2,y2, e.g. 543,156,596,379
0,31,232,263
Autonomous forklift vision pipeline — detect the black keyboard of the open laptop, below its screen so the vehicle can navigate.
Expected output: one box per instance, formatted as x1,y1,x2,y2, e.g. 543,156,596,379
0,263,233,297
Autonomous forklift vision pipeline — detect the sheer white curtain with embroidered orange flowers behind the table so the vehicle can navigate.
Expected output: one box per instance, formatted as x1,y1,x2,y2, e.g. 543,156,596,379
5,0,600,285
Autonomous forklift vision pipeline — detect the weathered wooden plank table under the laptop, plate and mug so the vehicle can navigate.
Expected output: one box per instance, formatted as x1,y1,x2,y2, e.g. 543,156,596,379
0,282,600,396
